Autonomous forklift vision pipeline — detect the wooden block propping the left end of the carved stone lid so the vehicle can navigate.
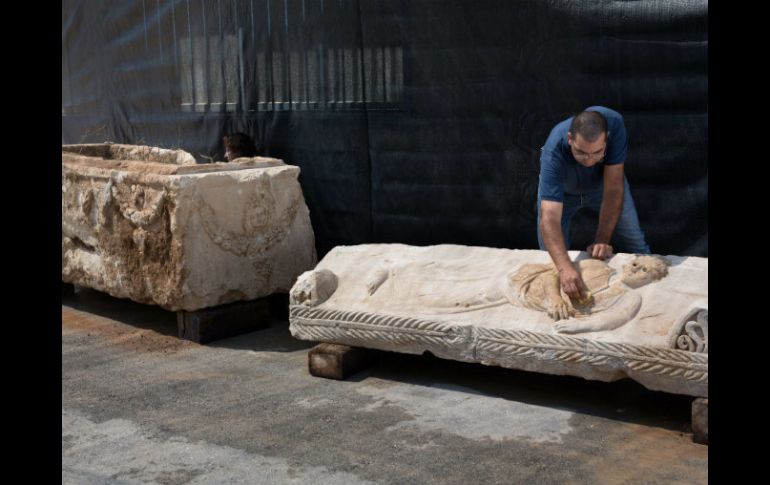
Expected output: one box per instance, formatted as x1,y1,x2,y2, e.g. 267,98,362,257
308,344,378,380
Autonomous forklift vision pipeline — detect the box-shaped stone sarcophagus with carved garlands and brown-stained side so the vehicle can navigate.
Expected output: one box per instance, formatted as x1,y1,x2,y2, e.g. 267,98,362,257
62,144,316,311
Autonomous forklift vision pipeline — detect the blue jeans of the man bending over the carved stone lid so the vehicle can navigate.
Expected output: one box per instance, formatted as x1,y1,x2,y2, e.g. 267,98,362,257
537,177,650,254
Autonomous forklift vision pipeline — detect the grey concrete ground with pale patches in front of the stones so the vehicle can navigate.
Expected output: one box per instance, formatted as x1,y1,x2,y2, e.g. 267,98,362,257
62,289,708,485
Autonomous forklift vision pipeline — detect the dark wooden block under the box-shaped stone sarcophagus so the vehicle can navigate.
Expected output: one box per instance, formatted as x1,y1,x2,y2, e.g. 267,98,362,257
176,298,270,344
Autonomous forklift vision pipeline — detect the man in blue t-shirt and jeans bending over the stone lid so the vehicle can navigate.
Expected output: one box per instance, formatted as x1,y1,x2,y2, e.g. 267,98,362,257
537,106,650,300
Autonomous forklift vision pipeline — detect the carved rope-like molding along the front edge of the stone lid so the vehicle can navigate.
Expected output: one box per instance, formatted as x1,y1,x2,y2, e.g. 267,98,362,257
291,305,708,384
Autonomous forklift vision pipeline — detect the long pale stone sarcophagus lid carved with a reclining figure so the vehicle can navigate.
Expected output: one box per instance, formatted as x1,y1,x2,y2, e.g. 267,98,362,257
289,244,708,397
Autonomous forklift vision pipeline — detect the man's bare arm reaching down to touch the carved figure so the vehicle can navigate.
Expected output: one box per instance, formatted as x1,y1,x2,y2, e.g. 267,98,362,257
540,199,584,299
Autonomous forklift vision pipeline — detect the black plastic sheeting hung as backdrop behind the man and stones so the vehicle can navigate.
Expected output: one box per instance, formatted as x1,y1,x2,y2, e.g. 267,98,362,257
62,0,708,256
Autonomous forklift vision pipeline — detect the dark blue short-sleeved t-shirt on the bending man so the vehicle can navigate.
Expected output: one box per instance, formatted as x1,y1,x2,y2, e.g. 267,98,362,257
538,106,628,202
